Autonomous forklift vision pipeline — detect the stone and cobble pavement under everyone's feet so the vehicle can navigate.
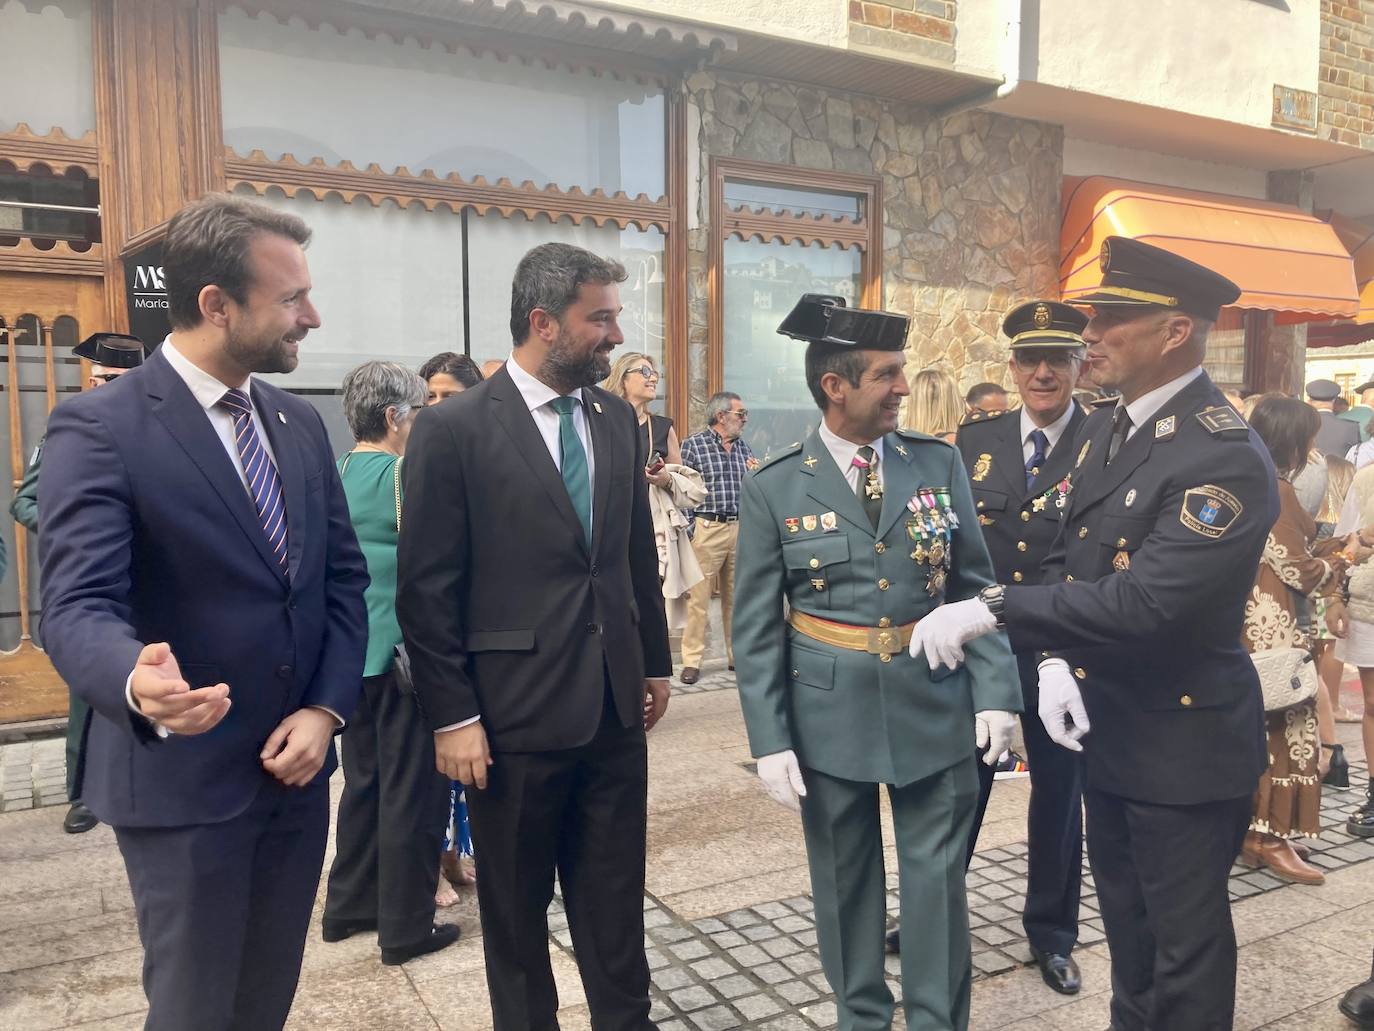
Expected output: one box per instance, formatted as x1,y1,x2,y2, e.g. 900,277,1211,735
0,670,1374,1031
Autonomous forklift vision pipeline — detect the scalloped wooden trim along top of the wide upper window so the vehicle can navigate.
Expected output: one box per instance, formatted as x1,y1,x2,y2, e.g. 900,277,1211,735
217,0,668,89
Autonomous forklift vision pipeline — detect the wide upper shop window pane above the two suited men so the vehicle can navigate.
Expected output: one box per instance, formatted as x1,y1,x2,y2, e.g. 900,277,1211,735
220,8,666,199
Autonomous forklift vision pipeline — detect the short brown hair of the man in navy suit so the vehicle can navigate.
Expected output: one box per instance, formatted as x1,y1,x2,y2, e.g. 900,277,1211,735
162,194,311,330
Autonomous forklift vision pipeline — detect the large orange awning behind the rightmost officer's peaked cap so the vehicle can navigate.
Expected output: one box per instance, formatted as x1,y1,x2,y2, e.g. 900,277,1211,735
1059,176,1357,322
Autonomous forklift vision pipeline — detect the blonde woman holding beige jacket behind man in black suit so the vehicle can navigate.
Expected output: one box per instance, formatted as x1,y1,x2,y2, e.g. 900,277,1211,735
602,351,706,630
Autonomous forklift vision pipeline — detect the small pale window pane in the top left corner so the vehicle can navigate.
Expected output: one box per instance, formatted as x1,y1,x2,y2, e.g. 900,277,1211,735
0,0,95,139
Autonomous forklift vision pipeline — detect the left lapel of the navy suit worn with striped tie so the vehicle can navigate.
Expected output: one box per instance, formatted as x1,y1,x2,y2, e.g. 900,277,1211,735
144,352,290,583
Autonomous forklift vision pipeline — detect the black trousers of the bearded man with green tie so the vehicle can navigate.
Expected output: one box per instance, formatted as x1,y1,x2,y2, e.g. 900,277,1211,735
467,697,654,1031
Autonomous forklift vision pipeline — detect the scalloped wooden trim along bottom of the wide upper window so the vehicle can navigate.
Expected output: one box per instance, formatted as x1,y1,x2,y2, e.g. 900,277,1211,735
224,148,672,232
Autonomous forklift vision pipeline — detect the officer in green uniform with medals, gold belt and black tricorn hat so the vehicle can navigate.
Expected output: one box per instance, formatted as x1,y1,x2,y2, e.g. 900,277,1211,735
734,294,1021,1031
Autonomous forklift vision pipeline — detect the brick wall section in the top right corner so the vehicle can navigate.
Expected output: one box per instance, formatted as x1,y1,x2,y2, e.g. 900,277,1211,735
1319,0,1374,150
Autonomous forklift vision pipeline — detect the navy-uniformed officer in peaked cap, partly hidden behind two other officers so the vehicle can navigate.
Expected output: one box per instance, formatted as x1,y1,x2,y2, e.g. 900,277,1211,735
955,301,1088,995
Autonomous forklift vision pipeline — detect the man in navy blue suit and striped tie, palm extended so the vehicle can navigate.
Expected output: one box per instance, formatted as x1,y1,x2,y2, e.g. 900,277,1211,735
38,195,367,1031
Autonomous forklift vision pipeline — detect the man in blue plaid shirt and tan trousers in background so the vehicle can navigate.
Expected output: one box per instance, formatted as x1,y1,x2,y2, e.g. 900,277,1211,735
680,392,758,683
